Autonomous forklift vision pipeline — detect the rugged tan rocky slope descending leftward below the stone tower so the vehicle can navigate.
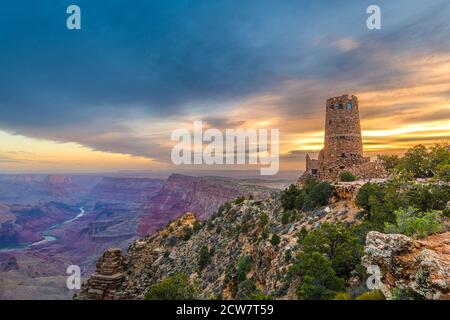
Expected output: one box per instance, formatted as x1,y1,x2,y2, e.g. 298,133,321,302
78,199,357,299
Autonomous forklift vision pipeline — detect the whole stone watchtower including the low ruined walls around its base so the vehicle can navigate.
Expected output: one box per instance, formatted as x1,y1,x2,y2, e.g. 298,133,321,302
299,95,387,184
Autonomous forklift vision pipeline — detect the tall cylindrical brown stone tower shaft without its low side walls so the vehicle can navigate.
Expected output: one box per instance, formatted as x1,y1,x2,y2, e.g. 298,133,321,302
319,95,367,172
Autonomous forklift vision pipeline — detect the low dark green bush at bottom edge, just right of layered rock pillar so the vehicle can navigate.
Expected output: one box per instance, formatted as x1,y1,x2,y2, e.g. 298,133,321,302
145,273,198,300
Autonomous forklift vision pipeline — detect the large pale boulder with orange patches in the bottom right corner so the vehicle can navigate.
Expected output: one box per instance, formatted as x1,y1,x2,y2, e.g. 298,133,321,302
363,231,450,300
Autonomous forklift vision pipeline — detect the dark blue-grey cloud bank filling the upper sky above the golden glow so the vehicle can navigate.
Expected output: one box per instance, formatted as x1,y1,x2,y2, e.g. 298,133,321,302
0,0,450,157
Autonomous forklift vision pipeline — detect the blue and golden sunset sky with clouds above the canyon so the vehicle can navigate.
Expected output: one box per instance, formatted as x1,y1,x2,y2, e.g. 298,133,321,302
0,0,450,172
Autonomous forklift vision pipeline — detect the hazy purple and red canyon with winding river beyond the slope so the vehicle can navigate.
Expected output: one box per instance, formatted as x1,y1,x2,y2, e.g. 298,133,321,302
0,174,287,299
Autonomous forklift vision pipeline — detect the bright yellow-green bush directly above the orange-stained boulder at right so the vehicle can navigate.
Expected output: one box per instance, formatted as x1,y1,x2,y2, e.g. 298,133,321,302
385,207,442,238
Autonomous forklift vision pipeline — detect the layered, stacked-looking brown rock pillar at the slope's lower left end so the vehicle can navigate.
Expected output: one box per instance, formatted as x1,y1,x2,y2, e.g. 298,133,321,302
76,248,126,300
